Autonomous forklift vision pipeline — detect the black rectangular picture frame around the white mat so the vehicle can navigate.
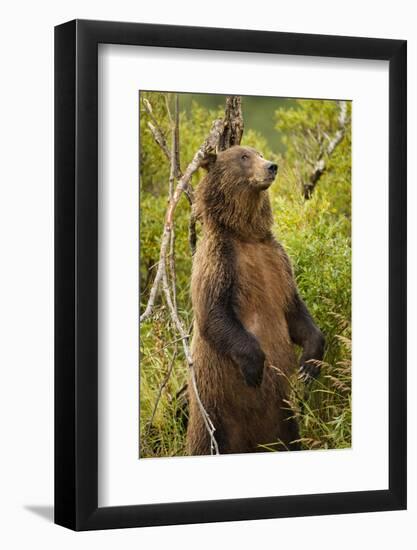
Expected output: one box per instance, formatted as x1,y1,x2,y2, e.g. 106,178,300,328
55,20,407,530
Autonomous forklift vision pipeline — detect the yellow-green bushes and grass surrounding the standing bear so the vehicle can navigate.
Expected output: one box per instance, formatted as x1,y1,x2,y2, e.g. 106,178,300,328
139,92,351,457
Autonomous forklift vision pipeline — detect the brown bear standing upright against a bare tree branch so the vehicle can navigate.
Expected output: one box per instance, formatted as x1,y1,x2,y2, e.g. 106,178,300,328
187,146,324,455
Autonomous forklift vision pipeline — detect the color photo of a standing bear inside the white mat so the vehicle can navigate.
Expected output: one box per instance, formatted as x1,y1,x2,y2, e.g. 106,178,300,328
138,91,352,459
